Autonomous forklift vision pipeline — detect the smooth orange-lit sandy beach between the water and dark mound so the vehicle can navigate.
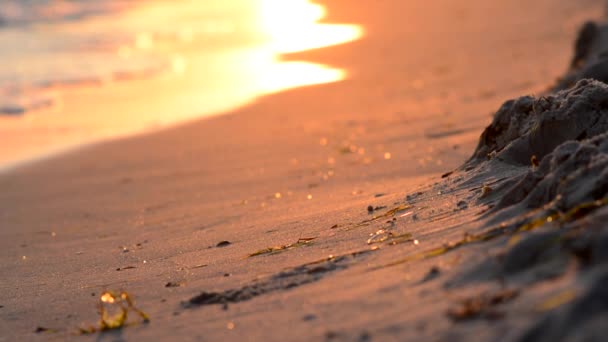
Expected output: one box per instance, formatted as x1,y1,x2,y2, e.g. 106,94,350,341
0,0,608,341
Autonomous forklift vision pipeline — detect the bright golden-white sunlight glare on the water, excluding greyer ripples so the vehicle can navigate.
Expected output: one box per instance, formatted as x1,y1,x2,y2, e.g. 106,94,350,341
0,0,363,166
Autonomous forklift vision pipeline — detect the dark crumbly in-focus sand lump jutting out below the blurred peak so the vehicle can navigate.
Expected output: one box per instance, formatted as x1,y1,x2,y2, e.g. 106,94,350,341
468,80,608,165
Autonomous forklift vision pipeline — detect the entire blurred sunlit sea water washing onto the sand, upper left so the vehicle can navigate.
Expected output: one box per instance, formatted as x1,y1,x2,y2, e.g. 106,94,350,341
0,0,363,167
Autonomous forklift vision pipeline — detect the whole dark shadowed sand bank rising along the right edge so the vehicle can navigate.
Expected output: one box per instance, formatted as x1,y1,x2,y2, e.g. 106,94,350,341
445,23,608,341
